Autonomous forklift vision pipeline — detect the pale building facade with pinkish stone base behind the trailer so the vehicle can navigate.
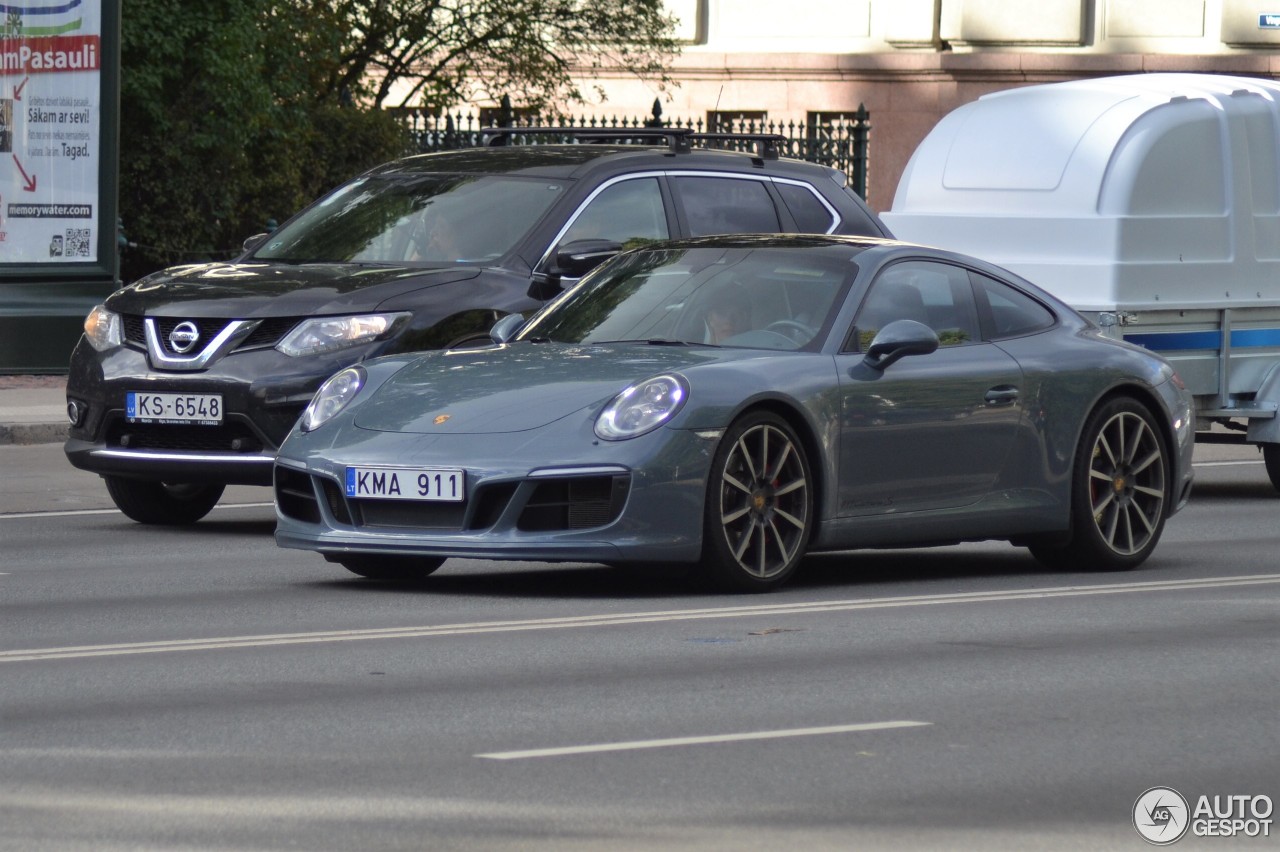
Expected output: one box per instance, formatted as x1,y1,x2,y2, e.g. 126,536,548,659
545,0,1280,210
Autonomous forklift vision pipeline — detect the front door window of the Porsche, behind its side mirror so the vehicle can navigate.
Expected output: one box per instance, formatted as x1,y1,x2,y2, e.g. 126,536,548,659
854,261,982,349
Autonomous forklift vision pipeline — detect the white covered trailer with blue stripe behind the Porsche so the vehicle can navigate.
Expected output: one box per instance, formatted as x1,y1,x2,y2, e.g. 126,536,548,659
883,74,1280,489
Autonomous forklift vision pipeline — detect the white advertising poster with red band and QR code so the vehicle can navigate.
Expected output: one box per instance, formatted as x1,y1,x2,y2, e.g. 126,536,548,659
0,0,102,264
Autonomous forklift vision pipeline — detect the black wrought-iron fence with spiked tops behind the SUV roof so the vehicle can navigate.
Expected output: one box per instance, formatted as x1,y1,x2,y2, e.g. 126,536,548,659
401,99,872,198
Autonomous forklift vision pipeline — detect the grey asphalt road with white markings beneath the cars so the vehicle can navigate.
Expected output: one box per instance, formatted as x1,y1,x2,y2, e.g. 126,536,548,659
0,446,1280,852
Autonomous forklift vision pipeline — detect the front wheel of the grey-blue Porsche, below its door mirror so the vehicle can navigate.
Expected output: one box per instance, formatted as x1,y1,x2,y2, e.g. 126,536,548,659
704,412,813,591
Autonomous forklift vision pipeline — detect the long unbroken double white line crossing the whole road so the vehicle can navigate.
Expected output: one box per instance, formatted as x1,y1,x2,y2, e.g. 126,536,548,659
0,574,1280,663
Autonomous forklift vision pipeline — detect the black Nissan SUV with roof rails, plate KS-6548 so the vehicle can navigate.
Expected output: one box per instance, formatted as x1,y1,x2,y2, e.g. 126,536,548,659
67,128,888,523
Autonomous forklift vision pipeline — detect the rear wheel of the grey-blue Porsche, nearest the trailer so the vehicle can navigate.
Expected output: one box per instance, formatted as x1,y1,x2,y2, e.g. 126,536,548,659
1032,398,1169,571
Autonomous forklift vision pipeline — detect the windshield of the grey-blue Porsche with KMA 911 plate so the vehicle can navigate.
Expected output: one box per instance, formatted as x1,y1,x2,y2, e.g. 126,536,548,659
518,247,858,349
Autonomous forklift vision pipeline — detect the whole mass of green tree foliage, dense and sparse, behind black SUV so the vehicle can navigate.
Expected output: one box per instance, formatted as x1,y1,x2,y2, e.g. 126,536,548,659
120,0,676,280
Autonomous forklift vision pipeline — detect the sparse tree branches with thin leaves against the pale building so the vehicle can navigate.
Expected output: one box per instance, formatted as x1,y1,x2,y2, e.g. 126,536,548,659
293,0,678,107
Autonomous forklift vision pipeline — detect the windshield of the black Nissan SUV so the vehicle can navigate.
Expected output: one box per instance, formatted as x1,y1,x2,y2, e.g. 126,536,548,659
252,174,563,266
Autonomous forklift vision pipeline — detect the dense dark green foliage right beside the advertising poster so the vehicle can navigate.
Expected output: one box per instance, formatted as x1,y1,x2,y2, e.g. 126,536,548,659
120,0,403,280
